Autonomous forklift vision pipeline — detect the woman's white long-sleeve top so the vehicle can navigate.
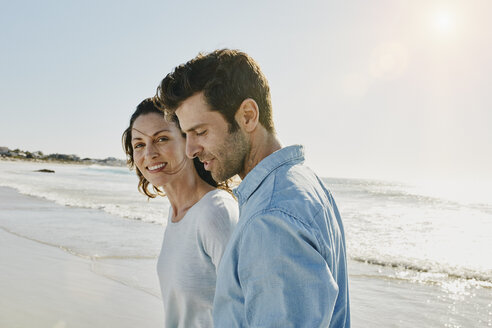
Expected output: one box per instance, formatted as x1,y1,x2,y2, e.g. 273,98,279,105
157,189,239,328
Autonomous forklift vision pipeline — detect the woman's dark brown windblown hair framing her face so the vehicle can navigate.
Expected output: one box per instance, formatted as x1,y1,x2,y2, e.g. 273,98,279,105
121,98,230,198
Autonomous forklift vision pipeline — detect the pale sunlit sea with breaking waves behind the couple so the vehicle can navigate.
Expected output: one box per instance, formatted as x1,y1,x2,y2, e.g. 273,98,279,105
0,161,492,327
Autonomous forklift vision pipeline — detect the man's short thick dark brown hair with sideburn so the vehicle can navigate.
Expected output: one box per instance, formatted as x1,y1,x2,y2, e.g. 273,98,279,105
156,49,275,133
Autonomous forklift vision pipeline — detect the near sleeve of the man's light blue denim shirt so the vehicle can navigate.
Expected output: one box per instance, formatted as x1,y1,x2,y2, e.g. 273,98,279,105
238,211,338,328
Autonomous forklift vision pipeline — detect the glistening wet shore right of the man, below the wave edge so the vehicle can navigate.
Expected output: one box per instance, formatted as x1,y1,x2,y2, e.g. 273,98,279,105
349,261,492,328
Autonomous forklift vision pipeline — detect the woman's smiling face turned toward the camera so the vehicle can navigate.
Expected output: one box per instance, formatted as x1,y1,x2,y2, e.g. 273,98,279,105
131,113,193,187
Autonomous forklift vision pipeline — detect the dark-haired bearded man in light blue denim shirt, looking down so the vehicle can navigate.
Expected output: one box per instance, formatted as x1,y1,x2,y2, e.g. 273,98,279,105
157,49,350,328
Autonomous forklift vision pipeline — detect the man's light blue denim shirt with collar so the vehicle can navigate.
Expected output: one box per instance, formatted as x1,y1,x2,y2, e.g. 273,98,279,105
213,146,350,328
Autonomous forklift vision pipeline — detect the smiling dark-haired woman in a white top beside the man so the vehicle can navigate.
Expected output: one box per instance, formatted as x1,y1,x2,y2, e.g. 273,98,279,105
123,98,239,327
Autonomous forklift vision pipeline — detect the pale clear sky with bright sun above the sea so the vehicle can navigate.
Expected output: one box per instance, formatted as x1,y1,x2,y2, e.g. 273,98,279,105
0,0,492,179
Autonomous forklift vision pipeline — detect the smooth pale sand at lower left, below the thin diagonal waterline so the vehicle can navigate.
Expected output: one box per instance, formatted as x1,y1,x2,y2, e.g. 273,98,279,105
0,229,163,328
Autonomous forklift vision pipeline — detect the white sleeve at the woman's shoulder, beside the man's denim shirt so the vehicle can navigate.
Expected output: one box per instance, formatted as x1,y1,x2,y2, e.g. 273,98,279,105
199,197,239,271
